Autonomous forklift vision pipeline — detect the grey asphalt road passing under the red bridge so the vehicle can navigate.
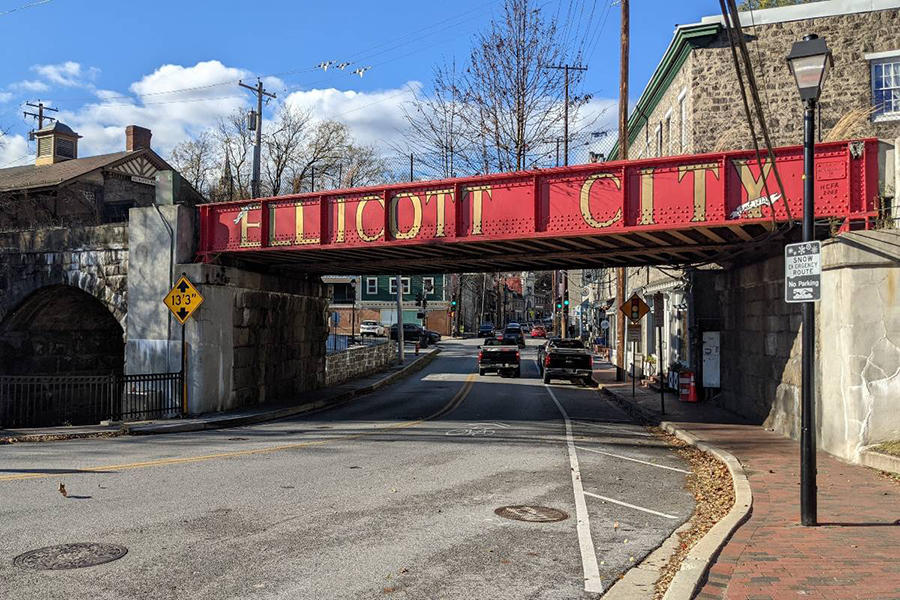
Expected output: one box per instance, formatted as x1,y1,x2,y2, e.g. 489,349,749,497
0,340,693,600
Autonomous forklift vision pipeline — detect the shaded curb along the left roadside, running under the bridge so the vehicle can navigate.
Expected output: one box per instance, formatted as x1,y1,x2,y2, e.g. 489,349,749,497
130,348,441,435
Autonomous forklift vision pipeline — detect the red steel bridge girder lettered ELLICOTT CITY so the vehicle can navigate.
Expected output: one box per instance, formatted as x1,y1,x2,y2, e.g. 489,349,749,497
199,139,878,262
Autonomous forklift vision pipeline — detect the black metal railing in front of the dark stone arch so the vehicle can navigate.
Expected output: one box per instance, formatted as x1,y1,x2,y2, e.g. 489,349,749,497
0,373,183,428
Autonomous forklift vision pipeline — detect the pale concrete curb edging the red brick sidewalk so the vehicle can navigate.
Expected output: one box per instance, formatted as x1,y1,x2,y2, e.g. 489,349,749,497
600,383,752,600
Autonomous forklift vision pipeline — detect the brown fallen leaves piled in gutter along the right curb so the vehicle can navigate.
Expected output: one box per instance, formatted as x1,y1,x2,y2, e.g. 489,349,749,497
648,427,734,600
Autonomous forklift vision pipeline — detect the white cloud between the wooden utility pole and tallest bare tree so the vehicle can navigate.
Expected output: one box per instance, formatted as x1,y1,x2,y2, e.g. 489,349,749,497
285,81,422,150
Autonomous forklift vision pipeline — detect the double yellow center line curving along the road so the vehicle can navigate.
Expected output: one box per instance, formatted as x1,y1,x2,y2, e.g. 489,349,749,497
0,373,475,481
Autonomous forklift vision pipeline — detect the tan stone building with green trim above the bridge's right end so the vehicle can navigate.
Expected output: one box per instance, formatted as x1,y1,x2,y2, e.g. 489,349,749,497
610,0,900,159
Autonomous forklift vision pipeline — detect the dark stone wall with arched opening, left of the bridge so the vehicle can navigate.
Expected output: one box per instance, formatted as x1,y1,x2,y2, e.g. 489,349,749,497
0,224,128,375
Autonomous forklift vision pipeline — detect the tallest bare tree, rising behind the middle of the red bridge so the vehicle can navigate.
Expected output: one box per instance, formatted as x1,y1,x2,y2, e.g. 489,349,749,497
407,0,589,173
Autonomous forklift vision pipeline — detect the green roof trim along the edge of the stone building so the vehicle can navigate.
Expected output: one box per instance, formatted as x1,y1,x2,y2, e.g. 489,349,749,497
607,23,722,160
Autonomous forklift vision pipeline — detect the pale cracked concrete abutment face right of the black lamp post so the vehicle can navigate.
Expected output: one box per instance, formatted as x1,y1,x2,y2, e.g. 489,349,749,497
816,230,900,461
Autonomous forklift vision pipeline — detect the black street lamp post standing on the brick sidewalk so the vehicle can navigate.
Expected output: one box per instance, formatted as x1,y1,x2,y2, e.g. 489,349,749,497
787,34,833,526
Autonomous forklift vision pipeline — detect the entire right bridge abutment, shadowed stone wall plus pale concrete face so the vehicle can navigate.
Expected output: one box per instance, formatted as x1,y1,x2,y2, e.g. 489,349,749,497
694,230,900,460
